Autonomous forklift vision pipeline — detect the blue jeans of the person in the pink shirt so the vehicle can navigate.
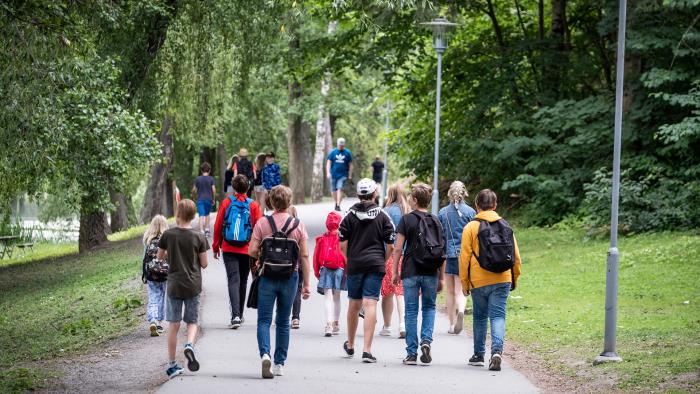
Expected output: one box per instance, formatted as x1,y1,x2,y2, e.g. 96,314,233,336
258,272,299,365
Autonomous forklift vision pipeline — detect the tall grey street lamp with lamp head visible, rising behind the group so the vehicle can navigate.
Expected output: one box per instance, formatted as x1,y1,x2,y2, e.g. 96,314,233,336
421,18,457,215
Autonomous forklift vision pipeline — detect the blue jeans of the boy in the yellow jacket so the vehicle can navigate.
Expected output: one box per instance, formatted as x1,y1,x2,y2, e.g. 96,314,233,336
472,282,510,356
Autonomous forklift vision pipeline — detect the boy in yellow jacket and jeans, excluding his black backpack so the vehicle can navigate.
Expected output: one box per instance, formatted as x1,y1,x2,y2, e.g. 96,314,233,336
459,189,521,371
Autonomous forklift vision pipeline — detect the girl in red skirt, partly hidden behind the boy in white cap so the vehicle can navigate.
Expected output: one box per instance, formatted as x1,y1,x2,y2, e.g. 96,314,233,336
379,184,411,338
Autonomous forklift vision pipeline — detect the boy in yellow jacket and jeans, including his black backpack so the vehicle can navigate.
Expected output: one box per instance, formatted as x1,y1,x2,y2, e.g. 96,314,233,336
459,189,521,371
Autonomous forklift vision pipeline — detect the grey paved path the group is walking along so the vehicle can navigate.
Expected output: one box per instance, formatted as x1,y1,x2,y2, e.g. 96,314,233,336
159,203,537,394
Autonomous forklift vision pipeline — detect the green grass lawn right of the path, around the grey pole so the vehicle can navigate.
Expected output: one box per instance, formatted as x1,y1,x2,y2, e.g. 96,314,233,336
504,228,700,392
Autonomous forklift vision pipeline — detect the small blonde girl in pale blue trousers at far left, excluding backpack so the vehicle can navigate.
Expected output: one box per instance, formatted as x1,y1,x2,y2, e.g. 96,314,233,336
142,215,168,337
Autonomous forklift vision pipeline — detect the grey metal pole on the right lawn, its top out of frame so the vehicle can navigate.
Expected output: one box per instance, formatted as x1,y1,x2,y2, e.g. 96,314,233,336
595,0,627,363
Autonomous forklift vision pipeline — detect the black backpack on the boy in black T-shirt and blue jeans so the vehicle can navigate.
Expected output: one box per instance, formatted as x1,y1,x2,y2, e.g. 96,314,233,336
411,212,445,269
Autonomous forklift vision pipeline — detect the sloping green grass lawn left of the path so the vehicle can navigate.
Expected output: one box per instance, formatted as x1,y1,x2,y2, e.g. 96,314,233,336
0,233,144,392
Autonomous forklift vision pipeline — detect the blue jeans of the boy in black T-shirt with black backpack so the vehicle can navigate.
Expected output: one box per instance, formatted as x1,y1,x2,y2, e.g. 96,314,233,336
403,275,438,356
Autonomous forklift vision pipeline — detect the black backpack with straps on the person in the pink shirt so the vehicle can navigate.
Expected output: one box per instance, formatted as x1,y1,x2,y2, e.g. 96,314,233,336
260,216,299,279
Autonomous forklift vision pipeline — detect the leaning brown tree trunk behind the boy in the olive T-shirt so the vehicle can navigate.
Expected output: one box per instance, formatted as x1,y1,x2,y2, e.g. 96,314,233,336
141,115,173,223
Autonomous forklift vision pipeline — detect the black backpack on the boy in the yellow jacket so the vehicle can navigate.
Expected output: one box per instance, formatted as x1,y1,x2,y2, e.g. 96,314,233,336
472,219,515,274
